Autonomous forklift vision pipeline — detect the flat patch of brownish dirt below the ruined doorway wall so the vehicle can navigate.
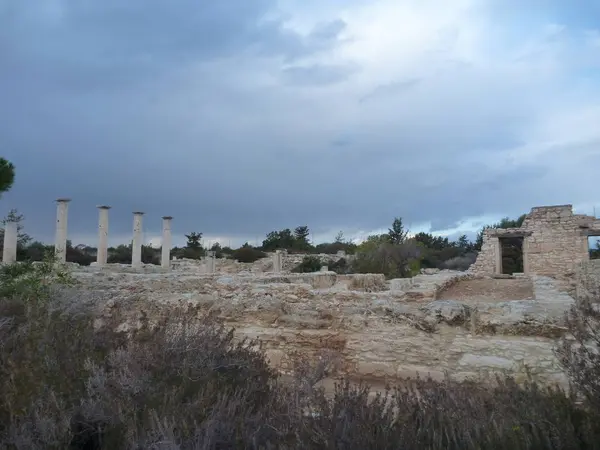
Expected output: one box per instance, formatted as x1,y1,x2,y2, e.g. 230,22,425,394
437,279,535,303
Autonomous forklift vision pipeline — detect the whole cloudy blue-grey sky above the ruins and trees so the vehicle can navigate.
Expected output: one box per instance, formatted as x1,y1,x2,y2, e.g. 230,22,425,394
0,0,600,245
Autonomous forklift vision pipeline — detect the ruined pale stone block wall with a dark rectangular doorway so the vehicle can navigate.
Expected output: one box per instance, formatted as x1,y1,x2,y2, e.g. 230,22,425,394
471,205,600,276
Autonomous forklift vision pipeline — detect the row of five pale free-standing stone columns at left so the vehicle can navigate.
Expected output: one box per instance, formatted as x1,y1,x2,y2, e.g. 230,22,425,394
2,198,173,269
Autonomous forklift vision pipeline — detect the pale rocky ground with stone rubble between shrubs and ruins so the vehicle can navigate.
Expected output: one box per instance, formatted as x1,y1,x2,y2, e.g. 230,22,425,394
61,260,573,390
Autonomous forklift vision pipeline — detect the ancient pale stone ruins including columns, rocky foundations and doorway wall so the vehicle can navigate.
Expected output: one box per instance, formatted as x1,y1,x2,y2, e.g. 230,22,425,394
4,199,600,390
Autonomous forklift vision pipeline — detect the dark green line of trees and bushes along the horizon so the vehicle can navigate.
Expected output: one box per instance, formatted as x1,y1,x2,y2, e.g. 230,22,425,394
0,158,600,277
